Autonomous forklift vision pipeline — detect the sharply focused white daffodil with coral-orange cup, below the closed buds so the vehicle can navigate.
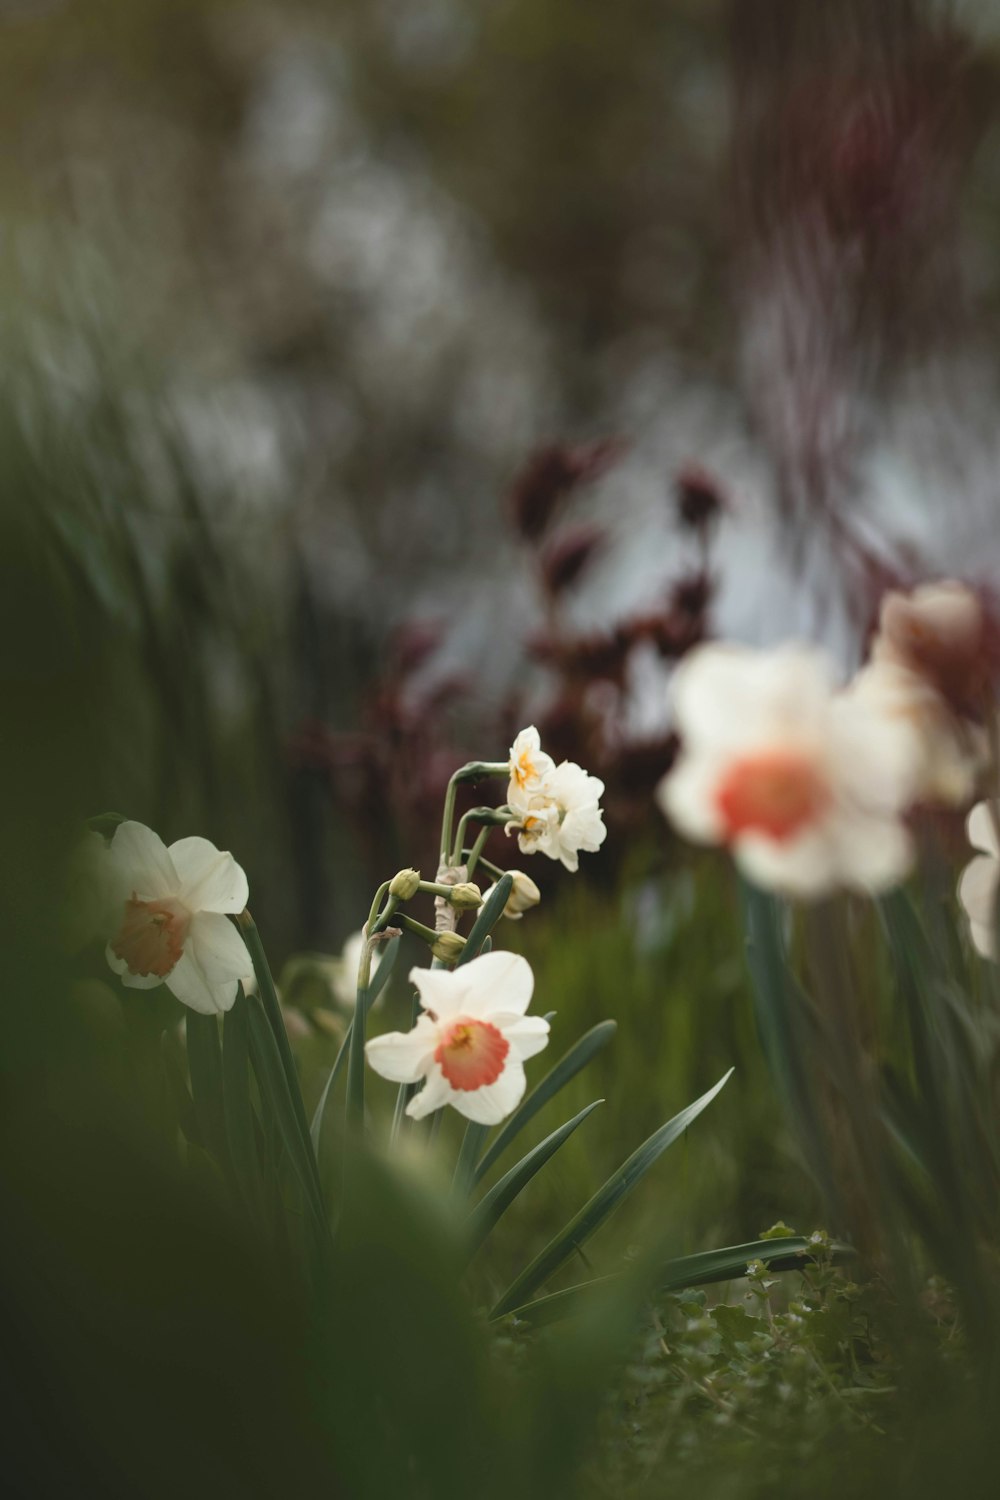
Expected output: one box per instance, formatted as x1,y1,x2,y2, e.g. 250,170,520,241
364,953,549,1125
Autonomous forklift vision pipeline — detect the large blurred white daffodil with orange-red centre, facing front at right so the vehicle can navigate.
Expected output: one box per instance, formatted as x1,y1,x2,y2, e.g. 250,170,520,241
657,645,918,897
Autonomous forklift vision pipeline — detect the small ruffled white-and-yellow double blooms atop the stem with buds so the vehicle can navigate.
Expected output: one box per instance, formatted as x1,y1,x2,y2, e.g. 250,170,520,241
505,725,607,870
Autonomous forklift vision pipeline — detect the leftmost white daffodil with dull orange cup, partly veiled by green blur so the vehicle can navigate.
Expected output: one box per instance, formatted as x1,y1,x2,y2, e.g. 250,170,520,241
105,822,253,1016
